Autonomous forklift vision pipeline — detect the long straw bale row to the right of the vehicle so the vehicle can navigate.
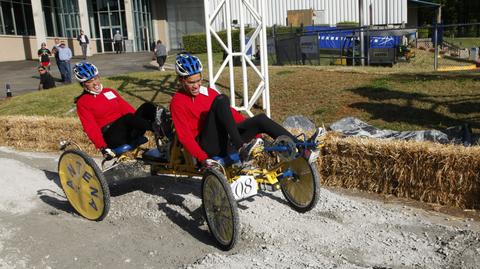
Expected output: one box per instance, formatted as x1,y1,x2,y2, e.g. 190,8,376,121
320,136,480,209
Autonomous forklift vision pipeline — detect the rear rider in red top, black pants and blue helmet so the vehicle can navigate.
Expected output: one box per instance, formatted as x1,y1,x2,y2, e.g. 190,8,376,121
73,62,156,159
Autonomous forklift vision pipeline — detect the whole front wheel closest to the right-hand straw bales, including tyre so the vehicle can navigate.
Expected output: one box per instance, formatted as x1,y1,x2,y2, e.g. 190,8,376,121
280,157,320,213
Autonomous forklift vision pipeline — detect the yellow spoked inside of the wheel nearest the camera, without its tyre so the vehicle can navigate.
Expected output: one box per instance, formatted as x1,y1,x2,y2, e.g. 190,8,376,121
203,175,234,245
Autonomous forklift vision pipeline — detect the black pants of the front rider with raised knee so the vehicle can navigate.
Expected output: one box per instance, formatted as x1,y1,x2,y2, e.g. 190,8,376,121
197,94,297,157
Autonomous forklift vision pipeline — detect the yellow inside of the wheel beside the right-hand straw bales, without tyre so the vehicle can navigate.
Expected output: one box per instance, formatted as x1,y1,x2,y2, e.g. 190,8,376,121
281,158,315,207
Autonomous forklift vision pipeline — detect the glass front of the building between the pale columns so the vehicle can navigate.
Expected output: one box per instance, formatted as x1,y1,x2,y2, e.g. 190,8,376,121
0,0,154,52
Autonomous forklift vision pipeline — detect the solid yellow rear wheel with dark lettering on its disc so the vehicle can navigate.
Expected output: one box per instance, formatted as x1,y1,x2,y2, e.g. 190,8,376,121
58,150,110,221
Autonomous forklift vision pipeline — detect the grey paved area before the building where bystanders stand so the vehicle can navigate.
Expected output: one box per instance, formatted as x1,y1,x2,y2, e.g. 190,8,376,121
0,52,172,99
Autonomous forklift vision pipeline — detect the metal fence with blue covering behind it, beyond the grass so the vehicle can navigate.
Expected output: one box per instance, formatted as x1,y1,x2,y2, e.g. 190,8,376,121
268,23,480,71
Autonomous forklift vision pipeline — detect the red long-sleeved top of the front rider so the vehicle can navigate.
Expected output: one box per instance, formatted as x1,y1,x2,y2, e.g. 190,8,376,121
170,87,245,161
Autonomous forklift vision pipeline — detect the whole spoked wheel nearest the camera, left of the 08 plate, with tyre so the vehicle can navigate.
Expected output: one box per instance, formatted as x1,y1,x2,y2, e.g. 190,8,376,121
202,169,240,250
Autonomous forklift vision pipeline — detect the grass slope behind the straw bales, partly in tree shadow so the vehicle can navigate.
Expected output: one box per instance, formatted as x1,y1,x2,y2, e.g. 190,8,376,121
0,58,480,130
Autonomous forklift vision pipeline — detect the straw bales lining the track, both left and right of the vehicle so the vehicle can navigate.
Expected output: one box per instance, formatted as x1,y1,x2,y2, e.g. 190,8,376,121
0,116,480,209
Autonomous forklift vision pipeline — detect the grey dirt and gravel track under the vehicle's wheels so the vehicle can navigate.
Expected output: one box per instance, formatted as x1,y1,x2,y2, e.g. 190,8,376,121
0,148,480,268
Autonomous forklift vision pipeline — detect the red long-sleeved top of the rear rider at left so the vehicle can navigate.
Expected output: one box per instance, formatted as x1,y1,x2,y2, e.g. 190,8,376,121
77,88,135,149
